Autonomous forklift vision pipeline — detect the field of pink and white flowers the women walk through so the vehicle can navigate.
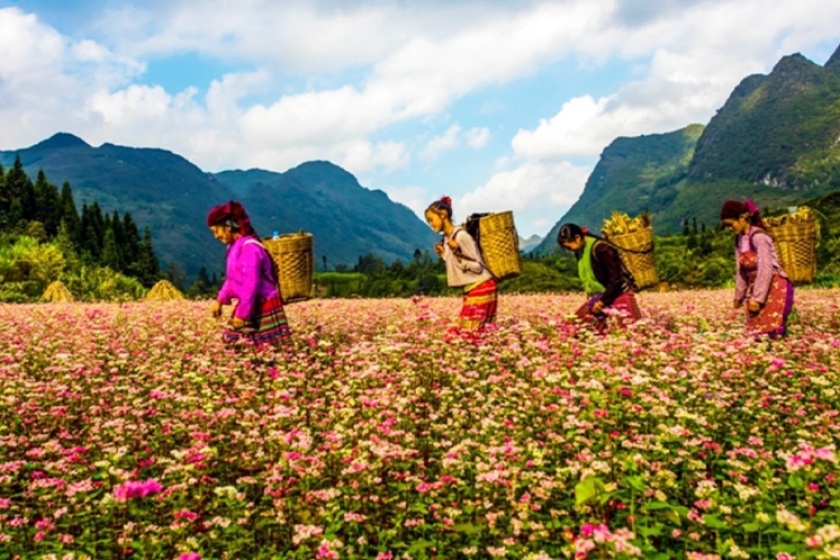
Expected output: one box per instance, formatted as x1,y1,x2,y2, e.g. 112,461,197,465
0,289,840,560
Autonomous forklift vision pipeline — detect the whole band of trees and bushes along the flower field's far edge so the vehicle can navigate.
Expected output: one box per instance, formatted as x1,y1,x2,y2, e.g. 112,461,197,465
0,153,840,301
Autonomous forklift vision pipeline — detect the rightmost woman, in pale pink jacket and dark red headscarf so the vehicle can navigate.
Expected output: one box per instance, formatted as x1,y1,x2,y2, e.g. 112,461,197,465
720,200,793,338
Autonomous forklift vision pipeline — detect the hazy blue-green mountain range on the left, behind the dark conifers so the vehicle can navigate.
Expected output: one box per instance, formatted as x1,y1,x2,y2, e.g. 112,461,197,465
0,133,436,277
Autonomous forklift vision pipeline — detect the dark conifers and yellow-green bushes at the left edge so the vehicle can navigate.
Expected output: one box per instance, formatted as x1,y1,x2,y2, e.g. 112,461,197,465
0,157,163,301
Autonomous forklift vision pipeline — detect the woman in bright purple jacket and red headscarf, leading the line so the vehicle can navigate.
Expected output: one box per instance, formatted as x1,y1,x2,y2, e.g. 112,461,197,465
207,200,291,346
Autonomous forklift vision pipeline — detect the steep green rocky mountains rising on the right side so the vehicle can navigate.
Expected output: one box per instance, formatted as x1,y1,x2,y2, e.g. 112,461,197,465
535,43,840,253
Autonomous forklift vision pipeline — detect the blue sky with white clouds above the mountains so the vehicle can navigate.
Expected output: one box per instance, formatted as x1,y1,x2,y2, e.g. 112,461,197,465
0,0,840,236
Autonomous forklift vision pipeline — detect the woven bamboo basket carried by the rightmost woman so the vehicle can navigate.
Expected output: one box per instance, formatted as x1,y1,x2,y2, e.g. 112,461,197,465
767,219,818,284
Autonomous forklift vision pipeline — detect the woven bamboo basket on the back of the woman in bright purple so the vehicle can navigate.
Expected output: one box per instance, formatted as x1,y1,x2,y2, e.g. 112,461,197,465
262,231,315,303
